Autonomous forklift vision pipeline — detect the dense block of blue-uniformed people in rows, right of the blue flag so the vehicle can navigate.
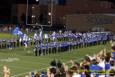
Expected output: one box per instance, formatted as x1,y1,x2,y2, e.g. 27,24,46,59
34,31,111,56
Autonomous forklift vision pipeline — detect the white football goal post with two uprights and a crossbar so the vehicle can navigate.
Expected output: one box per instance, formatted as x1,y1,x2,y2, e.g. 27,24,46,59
26,0,53,27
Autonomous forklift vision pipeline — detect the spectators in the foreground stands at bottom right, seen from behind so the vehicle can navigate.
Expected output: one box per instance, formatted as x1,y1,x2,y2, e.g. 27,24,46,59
20,43,115,77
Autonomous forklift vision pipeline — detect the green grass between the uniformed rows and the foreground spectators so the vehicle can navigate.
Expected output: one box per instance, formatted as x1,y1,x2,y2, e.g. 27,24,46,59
0,44,110,77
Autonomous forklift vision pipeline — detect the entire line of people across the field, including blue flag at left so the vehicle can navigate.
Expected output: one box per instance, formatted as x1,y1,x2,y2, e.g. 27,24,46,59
0,29,112,56
